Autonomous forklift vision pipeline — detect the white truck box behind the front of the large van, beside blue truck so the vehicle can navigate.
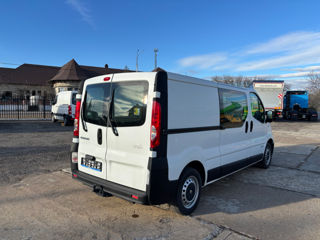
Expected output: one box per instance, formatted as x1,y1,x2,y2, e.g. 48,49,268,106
253,80,284,119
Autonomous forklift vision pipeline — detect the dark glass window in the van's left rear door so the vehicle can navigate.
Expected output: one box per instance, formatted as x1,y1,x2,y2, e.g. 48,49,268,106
83,83,110,126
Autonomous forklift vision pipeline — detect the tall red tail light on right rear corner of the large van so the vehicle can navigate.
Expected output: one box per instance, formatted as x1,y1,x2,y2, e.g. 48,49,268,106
150,100,161,148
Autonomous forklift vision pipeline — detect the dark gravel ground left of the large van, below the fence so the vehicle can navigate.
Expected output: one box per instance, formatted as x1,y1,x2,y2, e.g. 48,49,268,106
0,121,73,185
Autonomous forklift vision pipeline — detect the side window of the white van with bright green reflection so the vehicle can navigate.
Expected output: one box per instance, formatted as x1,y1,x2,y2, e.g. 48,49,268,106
219,89,248,128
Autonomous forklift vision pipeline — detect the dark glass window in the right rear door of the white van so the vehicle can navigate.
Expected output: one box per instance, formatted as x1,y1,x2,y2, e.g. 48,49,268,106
112,81,148,127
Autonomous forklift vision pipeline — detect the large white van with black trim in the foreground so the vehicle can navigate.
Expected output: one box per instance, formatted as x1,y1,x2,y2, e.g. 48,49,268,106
71,71,274,214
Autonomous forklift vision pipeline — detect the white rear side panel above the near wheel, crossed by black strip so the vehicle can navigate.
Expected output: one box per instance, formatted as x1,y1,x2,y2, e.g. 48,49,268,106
167,79,220,180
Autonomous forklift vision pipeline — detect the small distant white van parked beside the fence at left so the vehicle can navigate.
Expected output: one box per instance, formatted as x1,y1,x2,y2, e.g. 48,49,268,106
51,91,77,126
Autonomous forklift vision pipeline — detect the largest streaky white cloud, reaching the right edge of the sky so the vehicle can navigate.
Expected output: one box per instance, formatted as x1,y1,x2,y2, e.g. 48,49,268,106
179,32,320,74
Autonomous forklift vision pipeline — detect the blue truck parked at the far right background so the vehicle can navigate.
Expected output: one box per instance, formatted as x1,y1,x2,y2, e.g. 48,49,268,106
283,91,318,121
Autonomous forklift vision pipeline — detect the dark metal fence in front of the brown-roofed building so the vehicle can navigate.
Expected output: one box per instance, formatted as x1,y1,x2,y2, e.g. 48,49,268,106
0,96,52,120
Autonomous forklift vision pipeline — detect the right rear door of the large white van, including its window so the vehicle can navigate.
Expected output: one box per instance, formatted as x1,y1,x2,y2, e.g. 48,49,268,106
106,74,150,191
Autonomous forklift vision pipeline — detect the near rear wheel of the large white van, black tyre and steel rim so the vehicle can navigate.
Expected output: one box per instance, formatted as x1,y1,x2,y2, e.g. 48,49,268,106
176,168,202,215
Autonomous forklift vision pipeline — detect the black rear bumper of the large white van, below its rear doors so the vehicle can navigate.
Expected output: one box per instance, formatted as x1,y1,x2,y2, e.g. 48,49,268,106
72,170,148,204
